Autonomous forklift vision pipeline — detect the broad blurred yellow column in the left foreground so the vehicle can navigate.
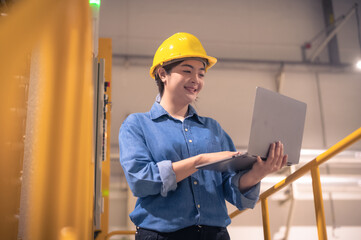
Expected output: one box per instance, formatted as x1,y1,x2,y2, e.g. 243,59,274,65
26,0,94,240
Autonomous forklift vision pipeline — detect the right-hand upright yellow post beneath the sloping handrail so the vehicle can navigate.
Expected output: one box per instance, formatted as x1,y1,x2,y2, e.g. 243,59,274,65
311,167,327,240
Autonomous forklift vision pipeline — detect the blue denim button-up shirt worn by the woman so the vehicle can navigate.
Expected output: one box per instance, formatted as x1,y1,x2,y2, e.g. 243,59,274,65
119,102,260,232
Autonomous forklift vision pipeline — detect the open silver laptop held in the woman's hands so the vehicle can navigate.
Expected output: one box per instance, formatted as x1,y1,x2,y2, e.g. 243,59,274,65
196,87,307,172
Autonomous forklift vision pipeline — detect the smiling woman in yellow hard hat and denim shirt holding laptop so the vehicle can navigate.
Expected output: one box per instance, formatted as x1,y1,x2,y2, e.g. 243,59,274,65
119,33,287,240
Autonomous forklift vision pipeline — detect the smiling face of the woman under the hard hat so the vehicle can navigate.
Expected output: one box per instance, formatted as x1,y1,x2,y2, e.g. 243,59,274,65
160,60,206,104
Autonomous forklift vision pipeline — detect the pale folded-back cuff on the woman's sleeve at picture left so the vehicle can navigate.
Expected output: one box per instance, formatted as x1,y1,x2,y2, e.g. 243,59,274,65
157,160,177,197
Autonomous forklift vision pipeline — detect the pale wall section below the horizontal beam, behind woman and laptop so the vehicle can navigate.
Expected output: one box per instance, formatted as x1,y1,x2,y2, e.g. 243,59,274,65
111,59,361,149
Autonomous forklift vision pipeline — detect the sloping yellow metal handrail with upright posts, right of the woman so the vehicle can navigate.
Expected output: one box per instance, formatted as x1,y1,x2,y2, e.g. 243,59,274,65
229,128,361,239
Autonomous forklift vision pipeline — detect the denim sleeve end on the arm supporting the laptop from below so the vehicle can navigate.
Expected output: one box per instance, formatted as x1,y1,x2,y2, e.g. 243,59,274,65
232,171,261,208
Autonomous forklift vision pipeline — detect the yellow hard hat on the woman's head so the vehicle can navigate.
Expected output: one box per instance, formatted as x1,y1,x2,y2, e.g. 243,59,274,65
149,32,217,78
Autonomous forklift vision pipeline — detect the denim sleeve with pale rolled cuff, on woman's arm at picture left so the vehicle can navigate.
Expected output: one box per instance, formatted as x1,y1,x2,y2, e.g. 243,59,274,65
119,115,177,197
